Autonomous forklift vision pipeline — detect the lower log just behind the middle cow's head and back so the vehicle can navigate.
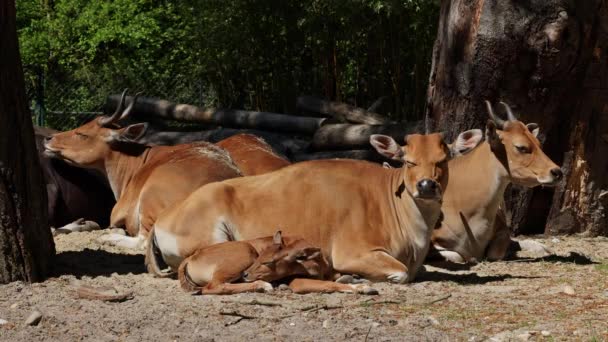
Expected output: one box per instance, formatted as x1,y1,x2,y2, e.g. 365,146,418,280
310,121,423,151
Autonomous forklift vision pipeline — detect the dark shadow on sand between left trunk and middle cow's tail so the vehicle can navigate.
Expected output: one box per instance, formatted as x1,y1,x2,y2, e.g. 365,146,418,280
52,249,146,278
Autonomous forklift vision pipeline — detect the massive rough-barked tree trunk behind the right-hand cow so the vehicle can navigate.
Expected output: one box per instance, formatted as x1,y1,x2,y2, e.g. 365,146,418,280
426,0,608,235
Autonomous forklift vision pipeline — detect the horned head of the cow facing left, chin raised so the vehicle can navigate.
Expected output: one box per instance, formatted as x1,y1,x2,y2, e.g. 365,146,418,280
44,90,147,168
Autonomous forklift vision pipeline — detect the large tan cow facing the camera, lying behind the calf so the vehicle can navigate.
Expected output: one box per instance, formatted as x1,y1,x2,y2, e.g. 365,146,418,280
147,131,482,283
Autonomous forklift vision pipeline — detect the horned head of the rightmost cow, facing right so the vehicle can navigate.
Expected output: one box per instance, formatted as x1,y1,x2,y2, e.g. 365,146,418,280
486,101,563,187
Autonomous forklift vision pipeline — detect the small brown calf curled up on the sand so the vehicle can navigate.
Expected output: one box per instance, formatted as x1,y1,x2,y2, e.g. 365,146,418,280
178,231,378,294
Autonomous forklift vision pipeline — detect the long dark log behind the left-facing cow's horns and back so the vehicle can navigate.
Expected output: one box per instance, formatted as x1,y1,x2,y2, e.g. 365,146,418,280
105,95,325,135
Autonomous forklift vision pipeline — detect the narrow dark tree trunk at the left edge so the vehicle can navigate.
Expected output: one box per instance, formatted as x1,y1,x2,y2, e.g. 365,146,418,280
0,0,55,283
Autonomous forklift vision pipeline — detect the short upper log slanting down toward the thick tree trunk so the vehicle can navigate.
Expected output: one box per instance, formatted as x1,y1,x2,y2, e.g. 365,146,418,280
296,96,392,125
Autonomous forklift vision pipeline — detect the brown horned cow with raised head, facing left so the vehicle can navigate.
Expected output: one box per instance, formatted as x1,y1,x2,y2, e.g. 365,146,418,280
45,90,288,248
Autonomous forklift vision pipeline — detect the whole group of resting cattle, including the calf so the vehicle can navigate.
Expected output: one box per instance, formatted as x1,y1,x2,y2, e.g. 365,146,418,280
36,93,562,294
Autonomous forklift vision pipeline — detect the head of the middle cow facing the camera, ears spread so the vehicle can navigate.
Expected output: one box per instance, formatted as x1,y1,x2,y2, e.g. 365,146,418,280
370,129,483,201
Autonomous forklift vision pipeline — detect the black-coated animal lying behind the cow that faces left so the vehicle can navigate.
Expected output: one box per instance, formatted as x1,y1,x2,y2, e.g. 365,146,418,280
34,127,116,233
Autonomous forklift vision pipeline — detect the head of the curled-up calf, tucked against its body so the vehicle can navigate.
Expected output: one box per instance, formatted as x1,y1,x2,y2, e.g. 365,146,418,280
243,231,329,282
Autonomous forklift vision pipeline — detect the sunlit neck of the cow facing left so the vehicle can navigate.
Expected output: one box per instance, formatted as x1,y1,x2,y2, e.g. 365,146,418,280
103,147,151,200
